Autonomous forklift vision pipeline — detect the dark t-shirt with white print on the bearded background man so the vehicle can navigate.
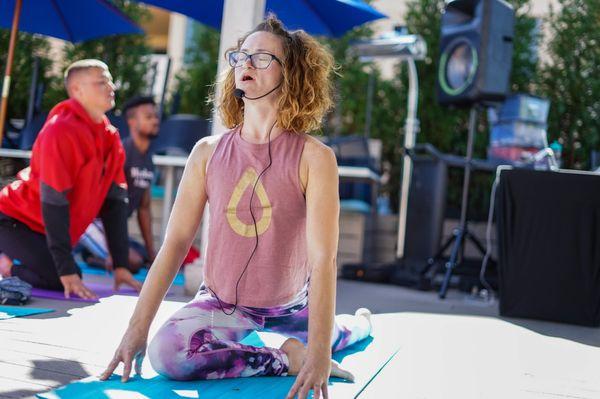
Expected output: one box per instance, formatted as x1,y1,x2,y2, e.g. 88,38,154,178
123,137,154,216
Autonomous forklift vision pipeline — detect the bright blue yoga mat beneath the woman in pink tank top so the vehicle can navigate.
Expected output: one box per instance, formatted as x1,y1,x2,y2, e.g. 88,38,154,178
37,333,398,399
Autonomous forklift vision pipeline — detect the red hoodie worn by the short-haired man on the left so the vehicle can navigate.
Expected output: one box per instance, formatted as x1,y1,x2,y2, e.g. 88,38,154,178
0,99,126,245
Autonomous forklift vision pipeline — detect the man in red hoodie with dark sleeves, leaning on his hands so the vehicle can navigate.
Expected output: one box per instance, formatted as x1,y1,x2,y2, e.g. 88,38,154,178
0,60,141,299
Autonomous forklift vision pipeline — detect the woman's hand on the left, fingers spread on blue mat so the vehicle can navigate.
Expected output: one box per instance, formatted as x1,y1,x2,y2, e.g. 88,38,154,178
100,327,148,382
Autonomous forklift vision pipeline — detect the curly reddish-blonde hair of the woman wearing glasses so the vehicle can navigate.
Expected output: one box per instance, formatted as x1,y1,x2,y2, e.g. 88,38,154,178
213,15,335,133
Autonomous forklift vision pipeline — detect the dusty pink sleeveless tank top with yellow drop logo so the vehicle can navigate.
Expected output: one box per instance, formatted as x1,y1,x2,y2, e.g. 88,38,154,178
204,129,309,308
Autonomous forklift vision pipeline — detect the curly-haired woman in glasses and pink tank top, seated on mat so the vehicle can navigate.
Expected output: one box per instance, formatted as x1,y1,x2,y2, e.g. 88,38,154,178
101,16,371,398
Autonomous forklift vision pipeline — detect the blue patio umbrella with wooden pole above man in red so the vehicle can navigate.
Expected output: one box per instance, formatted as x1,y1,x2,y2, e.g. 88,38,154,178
0,0,142,143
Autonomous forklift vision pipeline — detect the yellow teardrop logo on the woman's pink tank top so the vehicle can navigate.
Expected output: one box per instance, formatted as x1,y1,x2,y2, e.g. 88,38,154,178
227,167,272,237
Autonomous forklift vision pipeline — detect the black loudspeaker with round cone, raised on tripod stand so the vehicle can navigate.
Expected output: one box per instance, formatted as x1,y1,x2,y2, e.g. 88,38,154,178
437,0,515,106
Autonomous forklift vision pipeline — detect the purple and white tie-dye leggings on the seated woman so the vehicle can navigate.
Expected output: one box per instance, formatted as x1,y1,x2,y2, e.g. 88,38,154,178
148,289,370,380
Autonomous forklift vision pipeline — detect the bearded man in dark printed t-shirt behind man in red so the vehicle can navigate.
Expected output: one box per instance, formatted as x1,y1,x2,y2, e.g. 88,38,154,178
75,97,159,272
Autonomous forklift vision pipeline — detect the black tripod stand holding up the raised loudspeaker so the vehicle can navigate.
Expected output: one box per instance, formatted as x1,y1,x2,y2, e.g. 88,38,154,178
430,104,485,299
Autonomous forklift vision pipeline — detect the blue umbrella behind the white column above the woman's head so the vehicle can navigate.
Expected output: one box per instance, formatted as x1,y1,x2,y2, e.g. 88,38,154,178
132,0,387,37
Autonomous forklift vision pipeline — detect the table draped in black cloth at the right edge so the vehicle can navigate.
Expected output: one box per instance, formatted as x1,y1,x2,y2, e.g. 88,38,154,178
496,169,600,326
